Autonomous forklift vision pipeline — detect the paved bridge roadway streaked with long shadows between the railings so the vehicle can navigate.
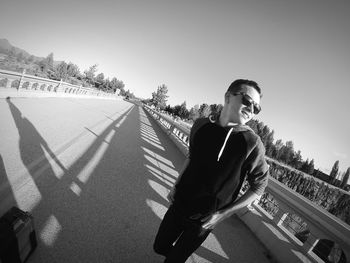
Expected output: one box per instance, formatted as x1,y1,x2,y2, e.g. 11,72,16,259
0,98,269,263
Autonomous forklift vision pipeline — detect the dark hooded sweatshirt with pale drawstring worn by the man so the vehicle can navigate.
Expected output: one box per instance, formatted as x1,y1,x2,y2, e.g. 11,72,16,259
175,118,268,217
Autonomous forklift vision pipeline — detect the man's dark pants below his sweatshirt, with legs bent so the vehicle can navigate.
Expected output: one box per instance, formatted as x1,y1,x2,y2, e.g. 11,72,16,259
153,205,211,263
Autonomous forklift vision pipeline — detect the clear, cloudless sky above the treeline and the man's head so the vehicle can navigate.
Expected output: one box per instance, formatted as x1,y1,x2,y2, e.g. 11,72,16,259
0,0,350,175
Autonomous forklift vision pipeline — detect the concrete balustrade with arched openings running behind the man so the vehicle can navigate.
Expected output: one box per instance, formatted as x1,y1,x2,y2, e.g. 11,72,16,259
144,106,350,263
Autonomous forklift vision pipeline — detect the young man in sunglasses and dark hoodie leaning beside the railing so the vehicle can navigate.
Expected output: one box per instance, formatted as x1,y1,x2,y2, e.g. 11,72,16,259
154,79,268,263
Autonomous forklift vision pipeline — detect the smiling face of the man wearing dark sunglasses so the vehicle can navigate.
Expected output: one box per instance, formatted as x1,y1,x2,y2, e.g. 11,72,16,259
226,85,260,124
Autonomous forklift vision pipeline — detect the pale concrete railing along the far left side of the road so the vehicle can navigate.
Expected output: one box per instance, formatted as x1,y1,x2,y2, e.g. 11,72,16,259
0,70,120,99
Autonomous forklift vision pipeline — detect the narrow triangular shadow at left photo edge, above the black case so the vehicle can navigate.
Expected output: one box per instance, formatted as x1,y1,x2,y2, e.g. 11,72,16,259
0,154,17,216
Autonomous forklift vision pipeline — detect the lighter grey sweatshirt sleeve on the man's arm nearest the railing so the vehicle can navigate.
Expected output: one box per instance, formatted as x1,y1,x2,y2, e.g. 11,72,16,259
246,138,269,196
